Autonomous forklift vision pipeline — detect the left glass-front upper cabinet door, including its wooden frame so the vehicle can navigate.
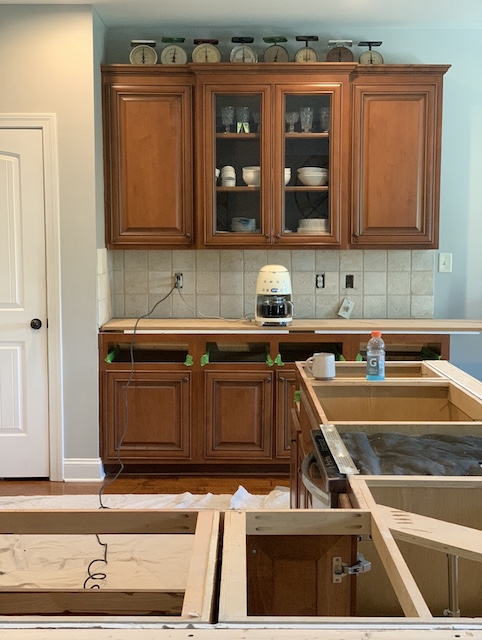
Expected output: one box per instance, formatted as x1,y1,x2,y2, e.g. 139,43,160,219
204,86,272,246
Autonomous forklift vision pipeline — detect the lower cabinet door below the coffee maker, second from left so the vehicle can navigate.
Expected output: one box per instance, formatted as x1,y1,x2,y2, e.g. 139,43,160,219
205,371,273,460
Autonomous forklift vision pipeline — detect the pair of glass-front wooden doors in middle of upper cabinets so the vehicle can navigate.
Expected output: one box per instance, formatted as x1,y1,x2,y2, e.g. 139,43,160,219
198,75,348,247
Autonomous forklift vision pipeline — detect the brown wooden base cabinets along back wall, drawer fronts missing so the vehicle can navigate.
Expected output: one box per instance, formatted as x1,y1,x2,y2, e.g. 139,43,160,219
99,331,449,472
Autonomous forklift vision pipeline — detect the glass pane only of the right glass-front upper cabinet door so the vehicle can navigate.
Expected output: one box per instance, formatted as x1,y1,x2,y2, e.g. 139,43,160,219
284,93,331,235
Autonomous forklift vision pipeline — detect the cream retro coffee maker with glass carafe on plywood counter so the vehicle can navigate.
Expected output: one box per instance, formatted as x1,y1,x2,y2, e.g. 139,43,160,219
255,264,294,327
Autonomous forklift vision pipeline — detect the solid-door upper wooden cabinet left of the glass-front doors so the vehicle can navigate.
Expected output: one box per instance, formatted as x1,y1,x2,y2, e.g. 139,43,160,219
103,67,193,249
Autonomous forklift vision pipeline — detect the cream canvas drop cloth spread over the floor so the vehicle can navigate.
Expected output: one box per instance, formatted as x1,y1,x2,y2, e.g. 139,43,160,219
0,486,289,590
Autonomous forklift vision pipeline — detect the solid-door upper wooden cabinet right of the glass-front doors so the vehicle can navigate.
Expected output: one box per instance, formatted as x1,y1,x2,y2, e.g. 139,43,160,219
350,65,448,249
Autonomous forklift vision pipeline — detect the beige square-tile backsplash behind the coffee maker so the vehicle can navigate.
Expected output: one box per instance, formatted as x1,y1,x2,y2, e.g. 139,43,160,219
99,249,435,321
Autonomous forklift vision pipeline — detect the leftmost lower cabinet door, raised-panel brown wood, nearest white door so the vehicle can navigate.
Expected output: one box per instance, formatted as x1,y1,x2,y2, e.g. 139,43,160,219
104,371,191,462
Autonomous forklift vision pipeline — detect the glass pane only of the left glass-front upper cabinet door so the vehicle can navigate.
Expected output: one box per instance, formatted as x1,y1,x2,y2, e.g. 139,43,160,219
213,94,261,234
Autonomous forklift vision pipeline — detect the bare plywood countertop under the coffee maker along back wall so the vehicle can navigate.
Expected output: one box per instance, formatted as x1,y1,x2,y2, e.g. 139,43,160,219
100,318,482,334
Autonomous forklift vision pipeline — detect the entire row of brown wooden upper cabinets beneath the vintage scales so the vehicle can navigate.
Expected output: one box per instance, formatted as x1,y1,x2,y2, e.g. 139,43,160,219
102,63,449,249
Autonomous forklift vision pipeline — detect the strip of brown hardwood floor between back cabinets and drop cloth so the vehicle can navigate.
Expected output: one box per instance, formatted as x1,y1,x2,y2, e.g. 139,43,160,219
0,475,289,496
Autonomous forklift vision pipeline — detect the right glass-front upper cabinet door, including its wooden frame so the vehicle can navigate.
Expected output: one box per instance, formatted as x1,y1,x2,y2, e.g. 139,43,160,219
274,85,345,245
